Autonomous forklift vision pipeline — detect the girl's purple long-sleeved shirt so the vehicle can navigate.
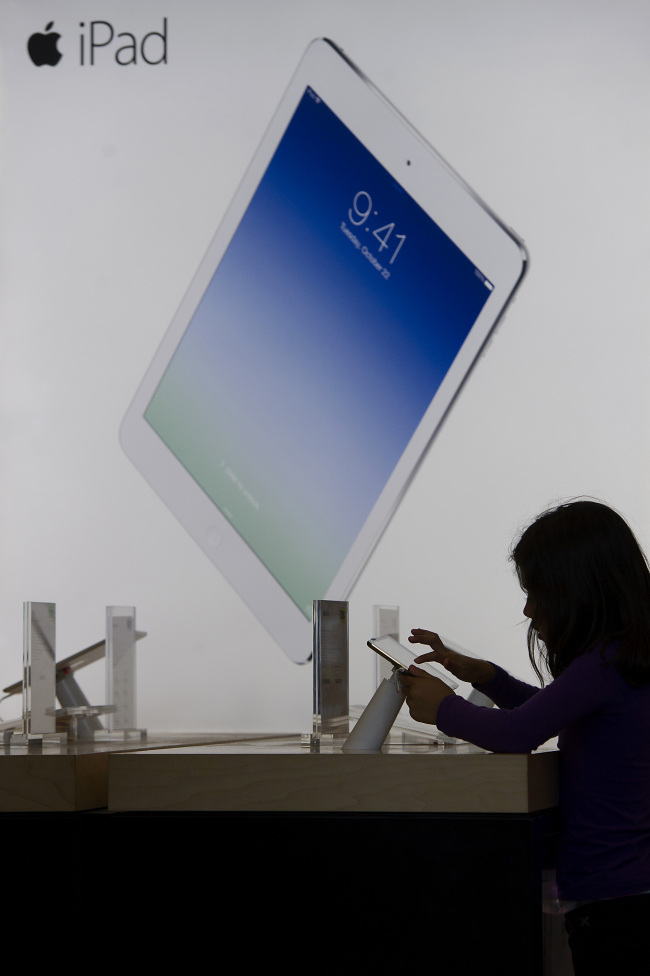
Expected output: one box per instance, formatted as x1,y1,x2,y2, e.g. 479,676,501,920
438,646,650,901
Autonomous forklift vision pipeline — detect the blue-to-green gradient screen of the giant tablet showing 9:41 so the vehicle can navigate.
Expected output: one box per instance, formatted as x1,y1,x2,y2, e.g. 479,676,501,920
145,89,490,618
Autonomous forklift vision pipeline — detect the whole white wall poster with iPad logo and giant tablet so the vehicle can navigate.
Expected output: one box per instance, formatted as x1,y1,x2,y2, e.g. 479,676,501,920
0,0,649,731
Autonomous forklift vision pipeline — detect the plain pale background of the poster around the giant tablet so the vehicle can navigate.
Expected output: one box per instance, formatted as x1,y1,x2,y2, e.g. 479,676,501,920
0,0,650,731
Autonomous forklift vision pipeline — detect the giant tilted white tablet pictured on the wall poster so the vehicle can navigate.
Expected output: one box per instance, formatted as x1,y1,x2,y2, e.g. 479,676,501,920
121,40,526,662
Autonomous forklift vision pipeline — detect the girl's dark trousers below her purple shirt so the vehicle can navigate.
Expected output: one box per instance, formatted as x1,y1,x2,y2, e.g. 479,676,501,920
564,894,650,976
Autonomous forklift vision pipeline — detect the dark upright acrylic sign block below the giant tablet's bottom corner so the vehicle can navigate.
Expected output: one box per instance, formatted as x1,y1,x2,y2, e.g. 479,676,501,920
308,600,350,749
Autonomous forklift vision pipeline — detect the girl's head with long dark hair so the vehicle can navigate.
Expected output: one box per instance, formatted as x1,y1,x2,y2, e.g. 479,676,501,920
510,500,650,685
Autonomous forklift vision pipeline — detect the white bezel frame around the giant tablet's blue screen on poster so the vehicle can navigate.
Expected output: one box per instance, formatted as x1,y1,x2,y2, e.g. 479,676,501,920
120,40,527,663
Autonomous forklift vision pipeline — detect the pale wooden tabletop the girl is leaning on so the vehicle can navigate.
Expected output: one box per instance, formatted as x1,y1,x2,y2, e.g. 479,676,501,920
108,736,558,814
